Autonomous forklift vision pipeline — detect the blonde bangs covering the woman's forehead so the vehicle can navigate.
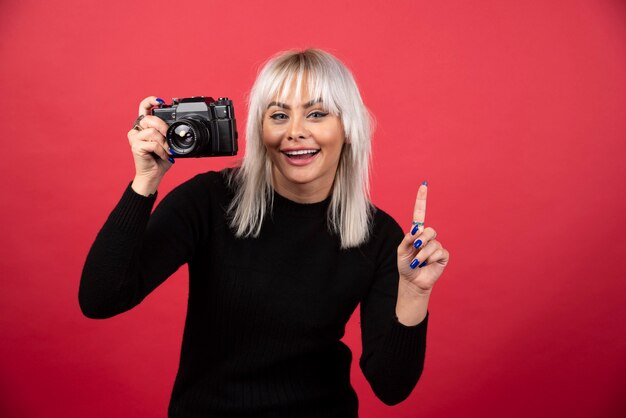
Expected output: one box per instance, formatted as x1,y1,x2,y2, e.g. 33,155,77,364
259,54,345,115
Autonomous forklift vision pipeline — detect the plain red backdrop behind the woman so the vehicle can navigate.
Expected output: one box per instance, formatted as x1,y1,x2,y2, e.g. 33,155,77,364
0,0,626,418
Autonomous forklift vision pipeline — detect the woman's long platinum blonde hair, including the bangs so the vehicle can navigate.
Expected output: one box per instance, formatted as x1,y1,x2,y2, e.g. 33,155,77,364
228,49,374,248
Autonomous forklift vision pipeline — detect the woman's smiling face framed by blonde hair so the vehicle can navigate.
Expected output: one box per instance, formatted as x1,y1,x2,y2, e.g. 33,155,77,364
263,89,345,203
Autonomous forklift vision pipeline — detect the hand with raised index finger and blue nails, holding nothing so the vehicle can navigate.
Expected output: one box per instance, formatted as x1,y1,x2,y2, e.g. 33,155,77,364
398,184,450,295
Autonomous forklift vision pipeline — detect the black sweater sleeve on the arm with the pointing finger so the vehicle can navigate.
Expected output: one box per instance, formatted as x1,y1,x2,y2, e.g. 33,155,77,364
359,212,429,405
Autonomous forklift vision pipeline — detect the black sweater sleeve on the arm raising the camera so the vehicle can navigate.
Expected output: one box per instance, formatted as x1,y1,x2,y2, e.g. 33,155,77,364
78,176,209,319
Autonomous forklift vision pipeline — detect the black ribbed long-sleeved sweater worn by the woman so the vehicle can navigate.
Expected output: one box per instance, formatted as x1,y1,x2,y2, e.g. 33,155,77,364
79,172,428,418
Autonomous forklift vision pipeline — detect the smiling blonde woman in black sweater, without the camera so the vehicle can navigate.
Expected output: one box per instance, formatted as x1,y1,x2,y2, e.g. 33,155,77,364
79,49,448,417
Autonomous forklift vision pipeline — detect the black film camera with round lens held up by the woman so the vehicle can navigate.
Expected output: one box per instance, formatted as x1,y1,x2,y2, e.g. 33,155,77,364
152,96,238,158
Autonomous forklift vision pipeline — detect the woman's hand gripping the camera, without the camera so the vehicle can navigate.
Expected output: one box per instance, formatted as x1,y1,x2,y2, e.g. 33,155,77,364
128,96,174,196
